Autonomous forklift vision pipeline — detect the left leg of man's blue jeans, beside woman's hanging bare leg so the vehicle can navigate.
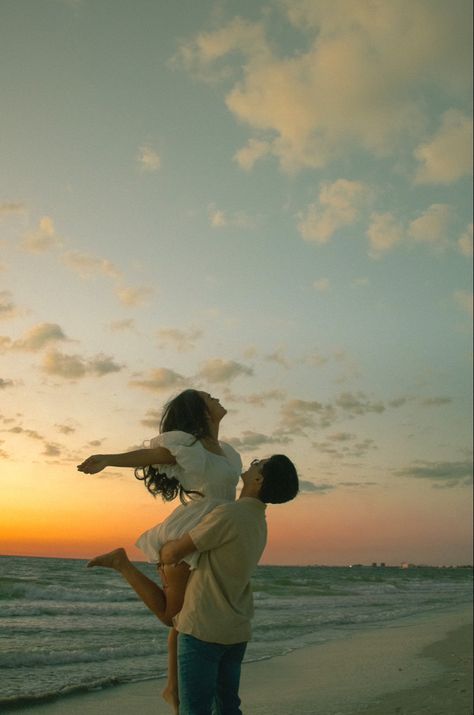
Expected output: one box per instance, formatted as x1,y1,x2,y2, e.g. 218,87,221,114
178,633,222,715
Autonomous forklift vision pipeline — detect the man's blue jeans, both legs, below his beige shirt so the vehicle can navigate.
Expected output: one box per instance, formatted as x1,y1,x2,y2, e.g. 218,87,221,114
178,633,247,715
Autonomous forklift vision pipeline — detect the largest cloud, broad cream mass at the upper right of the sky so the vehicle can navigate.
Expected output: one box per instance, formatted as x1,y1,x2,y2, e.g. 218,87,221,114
179,0,471,172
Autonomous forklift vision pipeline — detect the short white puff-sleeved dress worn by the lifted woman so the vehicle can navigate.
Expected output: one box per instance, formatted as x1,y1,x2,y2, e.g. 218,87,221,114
136,430,242,569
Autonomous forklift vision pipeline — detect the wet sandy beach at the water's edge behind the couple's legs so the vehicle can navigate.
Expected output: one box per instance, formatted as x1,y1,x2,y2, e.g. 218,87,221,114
10,607,472,715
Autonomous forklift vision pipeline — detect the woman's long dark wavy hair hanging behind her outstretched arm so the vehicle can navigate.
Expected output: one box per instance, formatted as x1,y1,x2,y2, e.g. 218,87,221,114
135,390,210,504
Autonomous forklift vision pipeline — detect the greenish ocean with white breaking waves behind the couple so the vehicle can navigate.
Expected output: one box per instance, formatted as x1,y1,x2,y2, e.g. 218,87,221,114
0,556,472,712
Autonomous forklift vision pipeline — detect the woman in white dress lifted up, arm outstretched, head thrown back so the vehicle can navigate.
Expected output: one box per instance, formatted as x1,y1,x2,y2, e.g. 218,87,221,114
77,390,242,713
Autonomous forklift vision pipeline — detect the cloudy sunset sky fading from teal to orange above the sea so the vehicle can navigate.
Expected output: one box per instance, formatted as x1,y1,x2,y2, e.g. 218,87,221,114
0,0,473,565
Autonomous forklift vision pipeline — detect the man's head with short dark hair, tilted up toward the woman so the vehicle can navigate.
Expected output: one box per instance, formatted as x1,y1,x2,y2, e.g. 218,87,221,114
241,454,299,504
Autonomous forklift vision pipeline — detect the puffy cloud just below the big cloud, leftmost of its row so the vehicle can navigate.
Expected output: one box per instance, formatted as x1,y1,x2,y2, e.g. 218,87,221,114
298,179,371,243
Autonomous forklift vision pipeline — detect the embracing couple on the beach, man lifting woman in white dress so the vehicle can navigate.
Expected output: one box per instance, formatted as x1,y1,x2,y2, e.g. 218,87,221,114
78,390,298,715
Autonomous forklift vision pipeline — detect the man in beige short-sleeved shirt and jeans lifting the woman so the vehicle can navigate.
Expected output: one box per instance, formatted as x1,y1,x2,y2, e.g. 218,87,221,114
160,454,299,715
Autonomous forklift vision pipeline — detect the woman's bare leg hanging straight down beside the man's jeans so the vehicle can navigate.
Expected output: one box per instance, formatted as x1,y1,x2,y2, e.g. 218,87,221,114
159,563,189,715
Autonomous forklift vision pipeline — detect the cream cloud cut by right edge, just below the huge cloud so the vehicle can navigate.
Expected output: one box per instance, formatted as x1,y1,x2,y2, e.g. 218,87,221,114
415,109,472,184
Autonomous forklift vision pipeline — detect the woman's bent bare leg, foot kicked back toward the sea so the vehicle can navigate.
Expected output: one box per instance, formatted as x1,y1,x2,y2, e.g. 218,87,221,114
87,548,170,626
